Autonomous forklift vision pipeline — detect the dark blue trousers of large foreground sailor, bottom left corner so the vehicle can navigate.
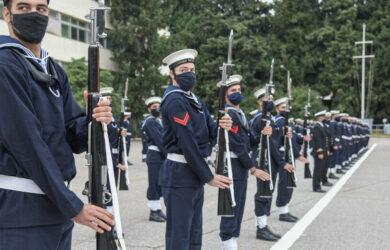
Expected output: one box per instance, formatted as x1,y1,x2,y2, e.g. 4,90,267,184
0,220,74,250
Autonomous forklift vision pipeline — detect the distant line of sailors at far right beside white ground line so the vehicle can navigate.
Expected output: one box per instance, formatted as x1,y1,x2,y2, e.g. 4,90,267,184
311,110,370,193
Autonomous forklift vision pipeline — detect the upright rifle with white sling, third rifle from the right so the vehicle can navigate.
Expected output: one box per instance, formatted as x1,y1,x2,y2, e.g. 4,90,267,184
258,59,274,198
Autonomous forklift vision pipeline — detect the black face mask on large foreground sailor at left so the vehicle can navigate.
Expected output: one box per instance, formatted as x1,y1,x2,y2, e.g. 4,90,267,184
11,12,49,43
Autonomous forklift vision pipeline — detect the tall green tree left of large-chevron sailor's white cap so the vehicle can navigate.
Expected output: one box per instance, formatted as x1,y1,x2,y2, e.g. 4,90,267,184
108,0,167,135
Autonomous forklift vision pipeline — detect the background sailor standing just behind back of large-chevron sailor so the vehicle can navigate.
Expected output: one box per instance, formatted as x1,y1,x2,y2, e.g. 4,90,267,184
142,96,167,222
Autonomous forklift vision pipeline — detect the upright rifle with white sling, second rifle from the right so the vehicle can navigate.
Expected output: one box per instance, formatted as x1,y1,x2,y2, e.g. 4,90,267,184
284,78,297,188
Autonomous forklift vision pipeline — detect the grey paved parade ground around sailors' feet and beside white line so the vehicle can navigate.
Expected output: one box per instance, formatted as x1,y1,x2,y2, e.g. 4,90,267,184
72,139,390,250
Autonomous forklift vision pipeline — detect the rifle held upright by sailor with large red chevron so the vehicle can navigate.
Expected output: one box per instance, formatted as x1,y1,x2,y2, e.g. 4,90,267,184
215,30,236,216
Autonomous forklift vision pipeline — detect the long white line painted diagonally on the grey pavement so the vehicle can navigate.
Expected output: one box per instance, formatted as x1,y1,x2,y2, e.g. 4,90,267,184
271,144,376,250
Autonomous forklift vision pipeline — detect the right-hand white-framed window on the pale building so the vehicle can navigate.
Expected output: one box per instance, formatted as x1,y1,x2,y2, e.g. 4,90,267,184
61,14,90,43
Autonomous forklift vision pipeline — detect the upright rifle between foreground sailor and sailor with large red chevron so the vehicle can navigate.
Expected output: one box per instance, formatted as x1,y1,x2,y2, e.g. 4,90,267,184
118,78,130,190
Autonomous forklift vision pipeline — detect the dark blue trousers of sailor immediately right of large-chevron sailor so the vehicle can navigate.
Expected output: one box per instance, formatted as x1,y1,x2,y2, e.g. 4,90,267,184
219,180,248,241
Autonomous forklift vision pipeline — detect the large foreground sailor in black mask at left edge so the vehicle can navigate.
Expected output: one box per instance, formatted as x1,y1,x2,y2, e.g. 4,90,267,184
0,0,114,249
